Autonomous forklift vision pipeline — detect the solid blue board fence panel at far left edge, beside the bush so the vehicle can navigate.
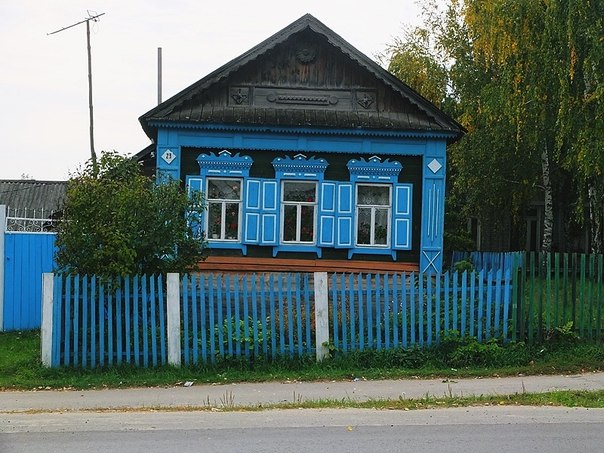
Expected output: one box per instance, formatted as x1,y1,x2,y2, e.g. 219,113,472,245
3,232,56,330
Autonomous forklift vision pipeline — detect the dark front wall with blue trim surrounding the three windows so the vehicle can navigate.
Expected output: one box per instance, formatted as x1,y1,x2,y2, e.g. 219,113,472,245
153,124,446,272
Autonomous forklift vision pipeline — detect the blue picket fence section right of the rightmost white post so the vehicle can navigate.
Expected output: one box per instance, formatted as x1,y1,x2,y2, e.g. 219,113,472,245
330,270,512,352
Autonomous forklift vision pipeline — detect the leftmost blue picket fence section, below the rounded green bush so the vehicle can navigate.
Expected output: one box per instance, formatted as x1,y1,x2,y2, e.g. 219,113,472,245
52,275,167,368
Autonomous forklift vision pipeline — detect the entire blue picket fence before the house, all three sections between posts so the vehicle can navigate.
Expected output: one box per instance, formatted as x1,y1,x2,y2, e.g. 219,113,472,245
52,270,512,367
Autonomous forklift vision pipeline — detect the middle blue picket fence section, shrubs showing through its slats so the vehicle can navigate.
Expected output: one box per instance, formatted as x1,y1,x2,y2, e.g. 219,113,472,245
181,273,315,364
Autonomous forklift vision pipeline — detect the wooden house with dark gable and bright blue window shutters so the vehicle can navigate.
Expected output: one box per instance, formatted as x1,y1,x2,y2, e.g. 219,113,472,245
139,15,463,272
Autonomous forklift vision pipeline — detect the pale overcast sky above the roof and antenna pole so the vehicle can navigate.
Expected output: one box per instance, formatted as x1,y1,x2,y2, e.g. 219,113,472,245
0,0,428,180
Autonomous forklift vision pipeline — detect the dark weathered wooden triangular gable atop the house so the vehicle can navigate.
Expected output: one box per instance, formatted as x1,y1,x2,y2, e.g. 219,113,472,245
140,15,461,138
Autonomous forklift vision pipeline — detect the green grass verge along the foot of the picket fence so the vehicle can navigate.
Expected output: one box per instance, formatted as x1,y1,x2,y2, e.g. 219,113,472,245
0,331,604,390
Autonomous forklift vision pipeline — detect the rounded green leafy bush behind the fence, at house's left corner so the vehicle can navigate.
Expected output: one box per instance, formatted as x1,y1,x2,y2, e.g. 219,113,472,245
56,152,206,277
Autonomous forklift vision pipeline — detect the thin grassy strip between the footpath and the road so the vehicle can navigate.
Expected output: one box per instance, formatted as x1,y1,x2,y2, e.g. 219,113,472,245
5,390,604,414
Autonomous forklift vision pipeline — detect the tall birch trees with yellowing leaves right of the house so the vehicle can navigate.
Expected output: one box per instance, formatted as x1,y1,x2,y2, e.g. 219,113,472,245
389,0,604,252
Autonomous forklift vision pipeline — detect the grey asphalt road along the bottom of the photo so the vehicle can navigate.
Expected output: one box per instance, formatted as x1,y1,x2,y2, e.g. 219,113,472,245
0,407,604,453
